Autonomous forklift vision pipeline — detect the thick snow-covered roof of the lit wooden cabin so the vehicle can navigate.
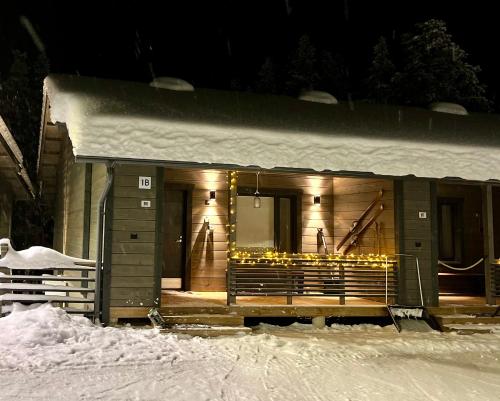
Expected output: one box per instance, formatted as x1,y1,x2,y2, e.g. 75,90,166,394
45,75,500,181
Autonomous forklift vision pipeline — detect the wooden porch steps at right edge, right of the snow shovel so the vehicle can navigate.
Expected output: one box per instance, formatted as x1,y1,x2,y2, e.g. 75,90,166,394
434,315,500,334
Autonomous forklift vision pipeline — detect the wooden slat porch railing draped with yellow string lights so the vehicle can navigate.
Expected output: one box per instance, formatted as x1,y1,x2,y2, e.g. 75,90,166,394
227,256,398,304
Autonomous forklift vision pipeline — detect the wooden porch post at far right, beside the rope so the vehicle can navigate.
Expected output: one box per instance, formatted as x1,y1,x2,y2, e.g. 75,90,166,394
482,184,496,305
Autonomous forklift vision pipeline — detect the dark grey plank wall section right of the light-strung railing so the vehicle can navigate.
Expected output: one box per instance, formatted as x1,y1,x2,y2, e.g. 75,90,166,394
394,179,438,306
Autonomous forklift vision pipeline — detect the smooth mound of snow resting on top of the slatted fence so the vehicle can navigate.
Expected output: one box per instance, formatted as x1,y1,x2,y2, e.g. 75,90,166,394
0,238,89,270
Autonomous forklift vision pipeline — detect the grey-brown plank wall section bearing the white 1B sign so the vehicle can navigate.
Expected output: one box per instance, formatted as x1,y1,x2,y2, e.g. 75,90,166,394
109,166,158,307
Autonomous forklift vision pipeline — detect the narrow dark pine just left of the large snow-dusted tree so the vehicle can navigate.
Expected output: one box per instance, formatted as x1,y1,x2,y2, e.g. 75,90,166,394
367,36,396,103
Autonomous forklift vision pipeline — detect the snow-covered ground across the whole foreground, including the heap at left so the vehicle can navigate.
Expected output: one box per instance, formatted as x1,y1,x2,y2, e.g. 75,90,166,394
0,305,500,401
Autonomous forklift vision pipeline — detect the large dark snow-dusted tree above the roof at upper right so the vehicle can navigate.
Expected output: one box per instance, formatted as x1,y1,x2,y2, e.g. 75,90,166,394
394,19,489,110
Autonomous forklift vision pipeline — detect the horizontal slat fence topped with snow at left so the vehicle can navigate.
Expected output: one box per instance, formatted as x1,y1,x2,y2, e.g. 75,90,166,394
0,239,95,315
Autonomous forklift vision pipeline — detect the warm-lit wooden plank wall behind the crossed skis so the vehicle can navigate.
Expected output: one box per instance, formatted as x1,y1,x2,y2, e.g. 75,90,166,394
333,177,396,255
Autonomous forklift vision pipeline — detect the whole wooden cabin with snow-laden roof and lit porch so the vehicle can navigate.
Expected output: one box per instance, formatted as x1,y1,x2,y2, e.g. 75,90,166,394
38,75,500,321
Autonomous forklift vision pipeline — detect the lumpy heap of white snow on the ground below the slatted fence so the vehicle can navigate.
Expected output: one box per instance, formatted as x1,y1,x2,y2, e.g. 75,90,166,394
0,304,202,371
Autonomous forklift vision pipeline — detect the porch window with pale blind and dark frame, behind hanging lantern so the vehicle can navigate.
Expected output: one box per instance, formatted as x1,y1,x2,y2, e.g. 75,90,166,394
236,189,299,253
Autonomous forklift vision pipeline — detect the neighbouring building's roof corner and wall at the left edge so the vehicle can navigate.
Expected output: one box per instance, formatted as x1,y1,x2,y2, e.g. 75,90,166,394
0,116,35,242
